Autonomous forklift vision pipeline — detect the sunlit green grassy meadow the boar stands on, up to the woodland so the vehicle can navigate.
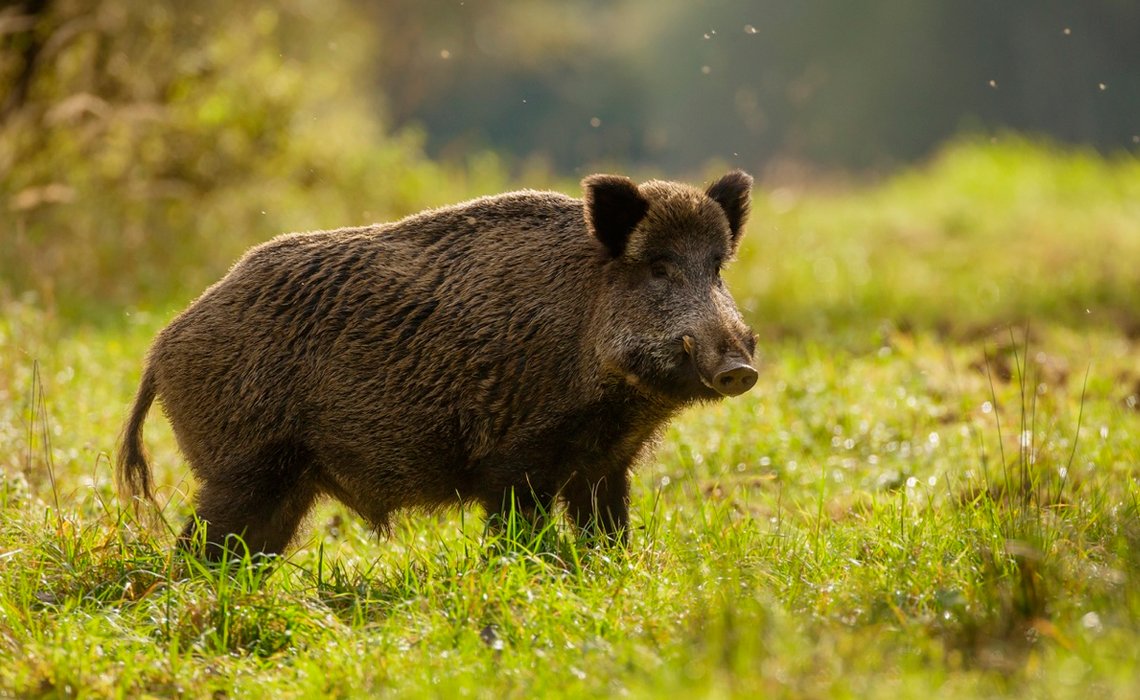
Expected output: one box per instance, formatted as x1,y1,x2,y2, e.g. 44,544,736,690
0,138,1140,699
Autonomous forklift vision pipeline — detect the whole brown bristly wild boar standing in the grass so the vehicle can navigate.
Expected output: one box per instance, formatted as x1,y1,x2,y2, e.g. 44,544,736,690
119,171,756,554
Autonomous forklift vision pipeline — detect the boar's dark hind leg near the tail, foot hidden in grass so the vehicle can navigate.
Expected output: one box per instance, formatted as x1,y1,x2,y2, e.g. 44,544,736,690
179,446,317,559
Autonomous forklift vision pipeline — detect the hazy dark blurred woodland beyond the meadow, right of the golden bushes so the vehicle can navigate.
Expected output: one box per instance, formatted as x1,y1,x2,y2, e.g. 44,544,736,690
369,0,1140,172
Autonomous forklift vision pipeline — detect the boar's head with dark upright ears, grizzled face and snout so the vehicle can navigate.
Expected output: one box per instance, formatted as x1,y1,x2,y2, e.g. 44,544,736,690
583,171,757,404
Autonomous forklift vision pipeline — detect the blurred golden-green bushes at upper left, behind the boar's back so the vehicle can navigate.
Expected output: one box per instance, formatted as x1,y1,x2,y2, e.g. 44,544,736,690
0,0,499,319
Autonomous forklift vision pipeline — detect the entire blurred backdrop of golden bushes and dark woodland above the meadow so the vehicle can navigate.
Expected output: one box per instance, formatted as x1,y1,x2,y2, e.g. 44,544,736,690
0,0,1140,319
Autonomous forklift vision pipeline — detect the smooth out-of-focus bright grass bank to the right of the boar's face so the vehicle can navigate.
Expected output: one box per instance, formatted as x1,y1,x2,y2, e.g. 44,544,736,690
731,135,1140,335
